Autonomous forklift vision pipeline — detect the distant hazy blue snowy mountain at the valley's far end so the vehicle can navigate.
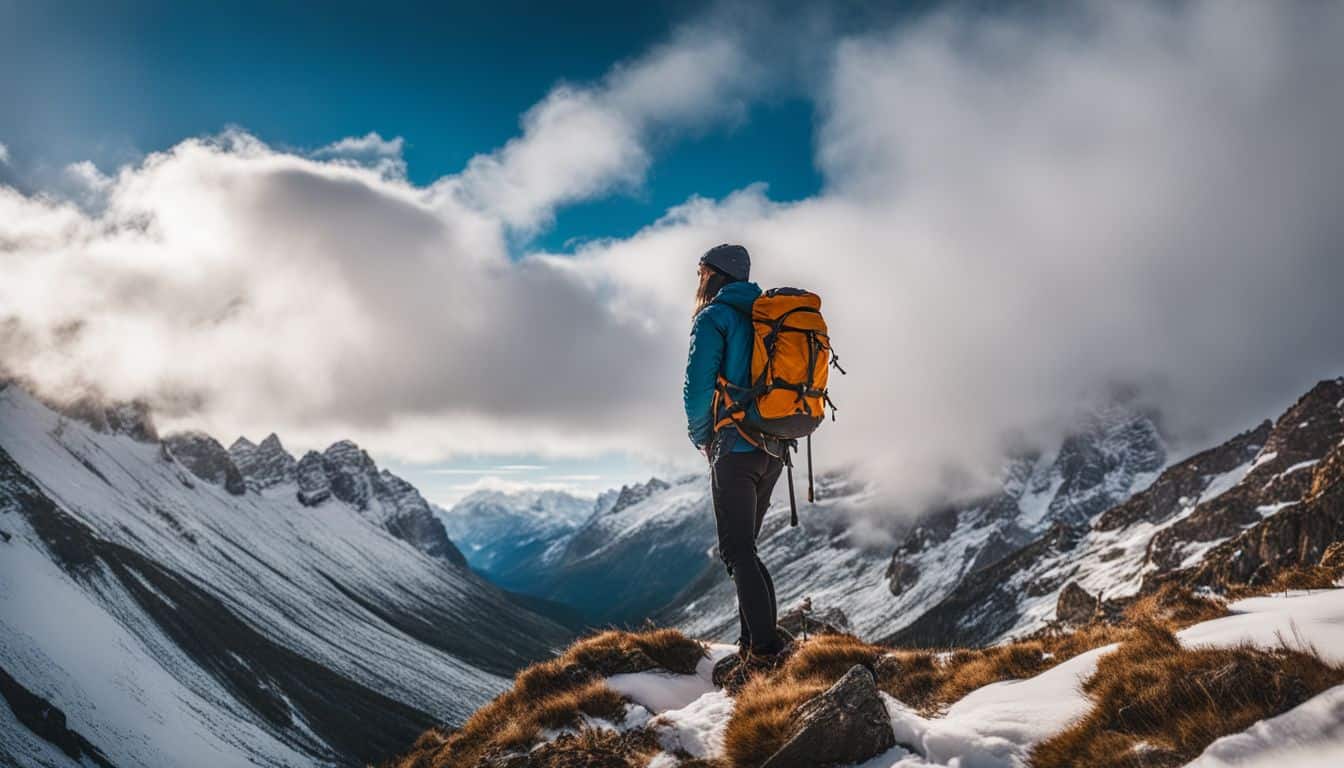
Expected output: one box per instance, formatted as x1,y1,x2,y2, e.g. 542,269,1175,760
438,491,594,593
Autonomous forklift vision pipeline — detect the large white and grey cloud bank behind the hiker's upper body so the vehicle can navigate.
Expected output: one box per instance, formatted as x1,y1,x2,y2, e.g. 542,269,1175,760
0,1,1344,503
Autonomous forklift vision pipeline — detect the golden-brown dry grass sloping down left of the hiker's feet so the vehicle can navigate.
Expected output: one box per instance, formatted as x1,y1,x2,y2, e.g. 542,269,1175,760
392,629,706,768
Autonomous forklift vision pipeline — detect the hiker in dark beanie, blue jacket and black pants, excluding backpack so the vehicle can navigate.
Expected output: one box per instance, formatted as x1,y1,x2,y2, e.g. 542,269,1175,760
681,243,788,664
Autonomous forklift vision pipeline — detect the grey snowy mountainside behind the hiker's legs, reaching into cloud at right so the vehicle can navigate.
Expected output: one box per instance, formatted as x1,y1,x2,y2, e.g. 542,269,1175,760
659,406,1167,640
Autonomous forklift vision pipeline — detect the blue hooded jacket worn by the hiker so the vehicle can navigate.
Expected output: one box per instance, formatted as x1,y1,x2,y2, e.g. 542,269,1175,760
681,281,761,452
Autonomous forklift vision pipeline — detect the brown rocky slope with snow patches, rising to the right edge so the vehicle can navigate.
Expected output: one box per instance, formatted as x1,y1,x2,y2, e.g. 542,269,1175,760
884,379,1344,644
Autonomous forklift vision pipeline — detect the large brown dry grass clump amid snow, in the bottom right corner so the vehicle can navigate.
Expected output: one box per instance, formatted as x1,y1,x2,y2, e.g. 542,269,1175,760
1031,623,1344,768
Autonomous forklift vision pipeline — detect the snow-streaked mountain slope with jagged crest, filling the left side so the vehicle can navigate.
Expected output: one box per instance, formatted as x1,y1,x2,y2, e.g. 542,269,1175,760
0,385,567,767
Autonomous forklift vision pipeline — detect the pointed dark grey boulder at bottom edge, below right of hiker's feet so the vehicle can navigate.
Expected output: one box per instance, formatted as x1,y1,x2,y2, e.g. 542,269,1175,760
762,664,896,768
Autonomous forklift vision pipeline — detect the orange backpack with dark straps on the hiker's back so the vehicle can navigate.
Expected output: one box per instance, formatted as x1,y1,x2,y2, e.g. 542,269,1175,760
714,288,844,526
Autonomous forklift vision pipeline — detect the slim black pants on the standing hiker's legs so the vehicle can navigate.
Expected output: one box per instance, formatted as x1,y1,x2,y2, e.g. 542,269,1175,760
711,451,784,654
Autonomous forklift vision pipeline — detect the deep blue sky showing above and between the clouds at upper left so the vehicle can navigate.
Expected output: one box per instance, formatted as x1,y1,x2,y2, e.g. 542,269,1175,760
0,0,820,250
